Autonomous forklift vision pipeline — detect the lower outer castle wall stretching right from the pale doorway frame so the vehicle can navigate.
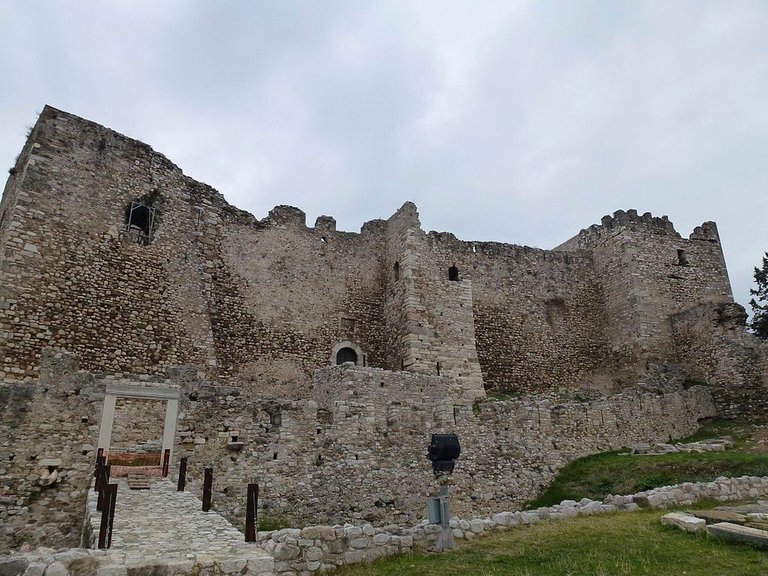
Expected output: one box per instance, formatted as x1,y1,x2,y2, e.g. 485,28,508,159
176,366,715,525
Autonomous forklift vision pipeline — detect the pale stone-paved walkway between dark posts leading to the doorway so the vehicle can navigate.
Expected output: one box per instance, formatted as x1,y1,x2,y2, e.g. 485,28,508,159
88,478,272,574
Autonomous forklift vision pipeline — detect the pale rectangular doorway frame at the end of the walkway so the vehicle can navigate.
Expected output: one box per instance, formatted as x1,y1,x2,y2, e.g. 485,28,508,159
97,382,181,463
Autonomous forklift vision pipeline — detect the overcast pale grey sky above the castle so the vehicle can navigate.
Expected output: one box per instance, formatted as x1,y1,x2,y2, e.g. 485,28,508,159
0,0,768,312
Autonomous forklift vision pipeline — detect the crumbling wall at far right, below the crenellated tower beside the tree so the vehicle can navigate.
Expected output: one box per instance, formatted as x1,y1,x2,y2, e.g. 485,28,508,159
672,303,768,421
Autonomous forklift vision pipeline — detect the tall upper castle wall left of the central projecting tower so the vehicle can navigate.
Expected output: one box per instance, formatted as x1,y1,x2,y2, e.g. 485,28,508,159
0,108,396,397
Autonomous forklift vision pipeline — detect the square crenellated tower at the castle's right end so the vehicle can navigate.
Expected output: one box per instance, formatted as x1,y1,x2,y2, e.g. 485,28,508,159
556,210,733,372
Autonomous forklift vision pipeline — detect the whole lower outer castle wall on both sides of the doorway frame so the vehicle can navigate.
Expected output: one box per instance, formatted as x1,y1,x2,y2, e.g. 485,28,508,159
0,351,715,549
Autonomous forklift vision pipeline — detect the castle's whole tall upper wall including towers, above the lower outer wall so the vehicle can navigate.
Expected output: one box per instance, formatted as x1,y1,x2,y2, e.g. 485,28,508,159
0,107,744,399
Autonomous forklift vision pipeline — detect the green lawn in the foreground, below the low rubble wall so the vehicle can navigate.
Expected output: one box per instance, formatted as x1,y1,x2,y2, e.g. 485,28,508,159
334,511,768,576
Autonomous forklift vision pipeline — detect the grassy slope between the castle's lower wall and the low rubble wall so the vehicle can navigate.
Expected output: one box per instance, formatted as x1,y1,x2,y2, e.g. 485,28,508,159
527,420,768,508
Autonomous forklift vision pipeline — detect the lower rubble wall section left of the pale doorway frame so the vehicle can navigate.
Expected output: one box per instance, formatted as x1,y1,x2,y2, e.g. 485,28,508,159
0,350,104,551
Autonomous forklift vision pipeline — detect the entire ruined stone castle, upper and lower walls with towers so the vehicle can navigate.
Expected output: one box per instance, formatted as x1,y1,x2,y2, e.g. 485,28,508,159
0,107,768,549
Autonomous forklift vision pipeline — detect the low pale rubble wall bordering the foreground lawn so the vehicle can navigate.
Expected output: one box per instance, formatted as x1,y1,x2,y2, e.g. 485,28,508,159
0,476,768,576
